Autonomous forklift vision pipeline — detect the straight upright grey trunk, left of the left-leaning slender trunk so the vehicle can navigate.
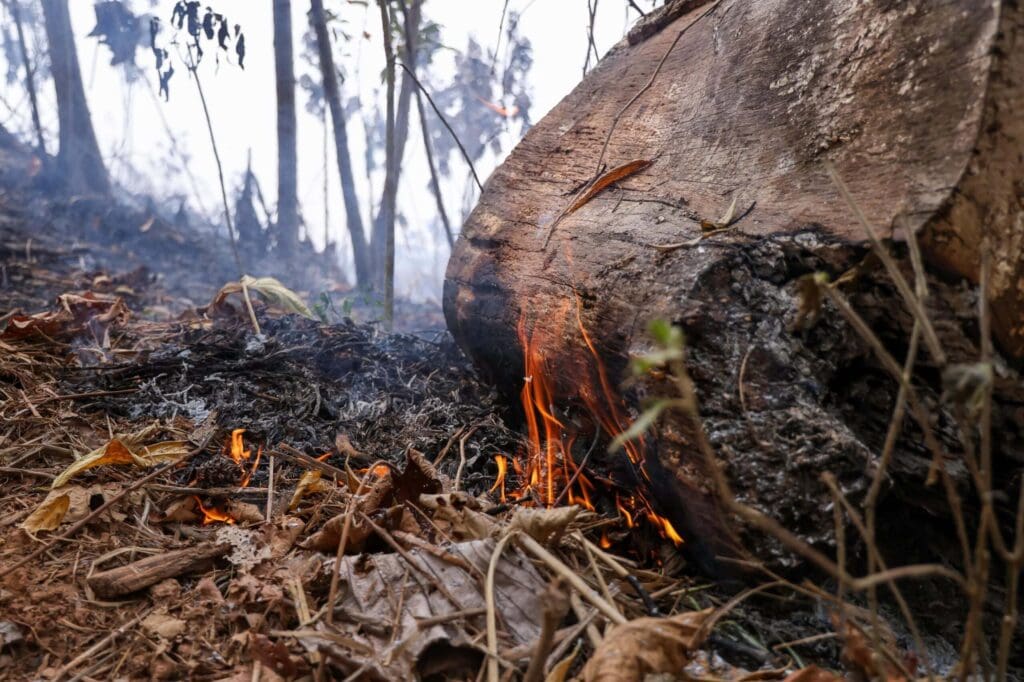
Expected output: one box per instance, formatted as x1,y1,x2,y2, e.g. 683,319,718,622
273,0,299,253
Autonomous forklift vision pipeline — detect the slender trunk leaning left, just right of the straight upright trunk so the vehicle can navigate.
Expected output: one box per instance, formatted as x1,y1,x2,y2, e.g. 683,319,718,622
310,0,373,289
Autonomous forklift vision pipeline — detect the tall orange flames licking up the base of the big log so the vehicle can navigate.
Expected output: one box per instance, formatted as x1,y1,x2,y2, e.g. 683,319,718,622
490,298,683,546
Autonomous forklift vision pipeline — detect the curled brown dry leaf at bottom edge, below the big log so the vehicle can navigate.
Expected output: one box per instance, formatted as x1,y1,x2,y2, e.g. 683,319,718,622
583,608,714,682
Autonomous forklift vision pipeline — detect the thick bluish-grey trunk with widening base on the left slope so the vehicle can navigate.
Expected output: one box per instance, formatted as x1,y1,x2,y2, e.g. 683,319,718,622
42,0,111,195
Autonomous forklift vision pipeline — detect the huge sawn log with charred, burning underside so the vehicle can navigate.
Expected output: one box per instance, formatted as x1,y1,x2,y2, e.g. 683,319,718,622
444,0,1024,565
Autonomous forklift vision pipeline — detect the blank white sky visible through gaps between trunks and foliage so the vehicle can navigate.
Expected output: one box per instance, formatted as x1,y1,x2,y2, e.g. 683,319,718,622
5,0,651,300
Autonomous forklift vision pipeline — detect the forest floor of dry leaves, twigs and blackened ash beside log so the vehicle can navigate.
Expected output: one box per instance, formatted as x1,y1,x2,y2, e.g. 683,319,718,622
0,140,999,682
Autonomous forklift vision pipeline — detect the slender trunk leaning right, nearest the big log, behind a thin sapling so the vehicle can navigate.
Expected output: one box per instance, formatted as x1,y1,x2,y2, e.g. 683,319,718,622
372,0,423,278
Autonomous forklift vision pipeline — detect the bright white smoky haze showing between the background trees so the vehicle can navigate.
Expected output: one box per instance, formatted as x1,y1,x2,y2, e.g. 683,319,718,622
2,0,636,301
